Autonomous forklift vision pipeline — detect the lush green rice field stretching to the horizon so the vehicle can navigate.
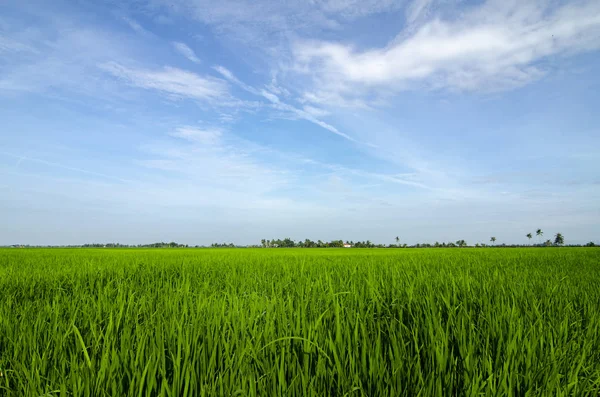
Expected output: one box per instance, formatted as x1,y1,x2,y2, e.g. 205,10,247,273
0,248,600,396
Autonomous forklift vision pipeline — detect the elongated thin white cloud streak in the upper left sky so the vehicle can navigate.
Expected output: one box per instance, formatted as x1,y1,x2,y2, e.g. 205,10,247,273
101,62,229,100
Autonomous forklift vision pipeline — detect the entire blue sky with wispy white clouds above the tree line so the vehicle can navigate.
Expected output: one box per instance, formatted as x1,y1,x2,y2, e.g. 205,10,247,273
0,0,600,245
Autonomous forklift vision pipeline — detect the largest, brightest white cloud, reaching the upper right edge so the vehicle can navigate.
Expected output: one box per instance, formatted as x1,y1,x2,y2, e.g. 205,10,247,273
293,0,600,97
